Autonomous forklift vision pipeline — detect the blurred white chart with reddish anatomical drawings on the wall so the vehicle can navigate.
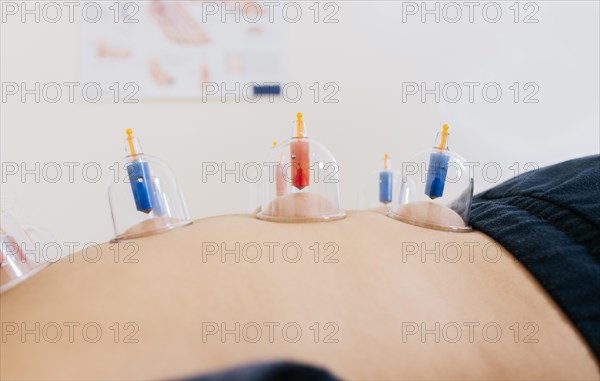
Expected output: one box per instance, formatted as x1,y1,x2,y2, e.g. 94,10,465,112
80,0,282,101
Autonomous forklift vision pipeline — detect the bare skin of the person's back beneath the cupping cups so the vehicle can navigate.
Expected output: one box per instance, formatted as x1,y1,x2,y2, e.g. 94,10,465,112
0,212,600,380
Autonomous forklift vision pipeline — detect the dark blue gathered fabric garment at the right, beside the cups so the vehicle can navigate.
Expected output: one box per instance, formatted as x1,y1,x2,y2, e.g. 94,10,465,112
470,155,600,359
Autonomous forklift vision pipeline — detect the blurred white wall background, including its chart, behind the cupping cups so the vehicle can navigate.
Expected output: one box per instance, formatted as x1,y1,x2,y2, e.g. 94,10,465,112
0,1,600,243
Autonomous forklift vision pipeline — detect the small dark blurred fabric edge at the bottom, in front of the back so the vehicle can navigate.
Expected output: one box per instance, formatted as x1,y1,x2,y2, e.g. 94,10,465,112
189,362,339,381
